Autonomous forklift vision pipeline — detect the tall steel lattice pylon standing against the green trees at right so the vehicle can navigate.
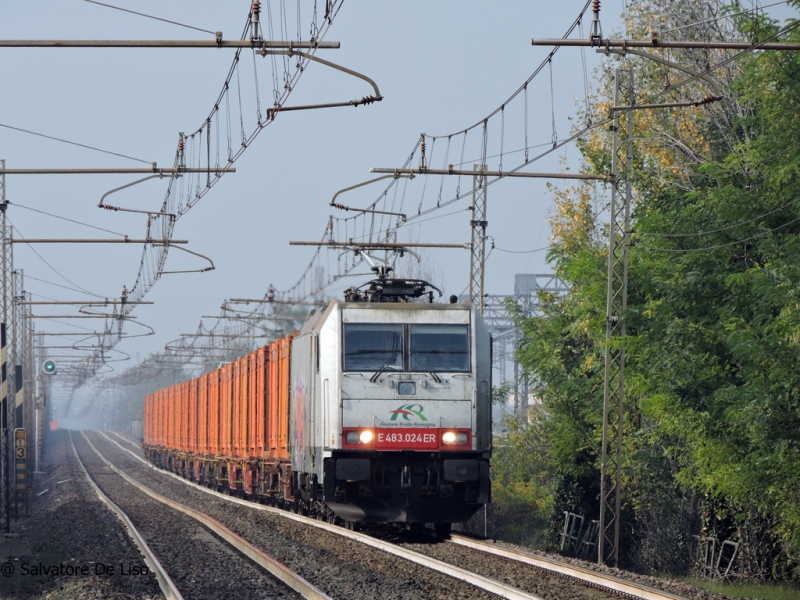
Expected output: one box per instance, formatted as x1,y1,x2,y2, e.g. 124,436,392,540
597,69,634,566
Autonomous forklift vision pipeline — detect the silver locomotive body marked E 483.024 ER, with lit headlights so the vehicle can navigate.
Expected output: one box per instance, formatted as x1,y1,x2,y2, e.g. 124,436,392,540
289,300,492,524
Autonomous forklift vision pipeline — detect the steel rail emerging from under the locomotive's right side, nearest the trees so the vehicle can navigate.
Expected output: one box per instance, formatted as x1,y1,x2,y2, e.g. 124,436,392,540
448,534,686,600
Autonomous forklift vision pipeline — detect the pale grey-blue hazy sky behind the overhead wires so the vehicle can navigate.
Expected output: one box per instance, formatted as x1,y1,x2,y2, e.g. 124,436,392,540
0,0,797,418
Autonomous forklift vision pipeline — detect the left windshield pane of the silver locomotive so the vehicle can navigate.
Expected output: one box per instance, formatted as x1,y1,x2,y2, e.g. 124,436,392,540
344,323,403,371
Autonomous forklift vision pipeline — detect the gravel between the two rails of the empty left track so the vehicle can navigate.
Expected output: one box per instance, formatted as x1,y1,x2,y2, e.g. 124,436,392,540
73,434,299,600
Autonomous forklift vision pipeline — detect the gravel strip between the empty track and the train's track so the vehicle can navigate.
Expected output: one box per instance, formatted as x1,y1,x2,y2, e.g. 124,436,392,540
89,433,497,600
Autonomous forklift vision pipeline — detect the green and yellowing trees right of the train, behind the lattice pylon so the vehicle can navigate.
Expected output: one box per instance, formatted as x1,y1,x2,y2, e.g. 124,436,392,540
510,0,800,578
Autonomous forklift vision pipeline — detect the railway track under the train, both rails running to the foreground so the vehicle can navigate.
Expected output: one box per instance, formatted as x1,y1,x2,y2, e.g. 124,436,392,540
100,433,682,600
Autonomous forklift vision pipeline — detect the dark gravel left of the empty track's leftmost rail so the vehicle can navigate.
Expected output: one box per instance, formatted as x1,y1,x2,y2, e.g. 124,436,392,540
0,430,163,600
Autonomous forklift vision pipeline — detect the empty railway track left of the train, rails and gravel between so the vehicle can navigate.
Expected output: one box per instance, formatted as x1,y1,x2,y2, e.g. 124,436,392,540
70,433,330,600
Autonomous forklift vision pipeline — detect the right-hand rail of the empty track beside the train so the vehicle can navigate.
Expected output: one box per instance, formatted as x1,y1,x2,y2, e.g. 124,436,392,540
81,431,333,600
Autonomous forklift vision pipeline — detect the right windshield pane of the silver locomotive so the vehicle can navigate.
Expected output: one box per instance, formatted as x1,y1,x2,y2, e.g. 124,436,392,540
410,325,469,373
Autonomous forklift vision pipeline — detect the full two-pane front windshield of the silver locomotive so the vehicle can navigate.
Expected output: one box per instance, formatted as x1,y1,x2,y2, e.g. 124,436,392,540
344,323,470,373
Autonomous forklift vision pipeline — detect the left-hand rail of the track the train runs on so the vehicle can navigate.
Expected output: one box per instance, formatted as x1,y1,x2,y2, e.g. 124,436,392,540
98,431,543,600
